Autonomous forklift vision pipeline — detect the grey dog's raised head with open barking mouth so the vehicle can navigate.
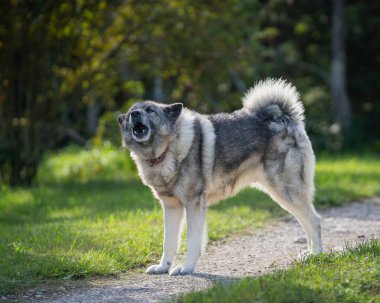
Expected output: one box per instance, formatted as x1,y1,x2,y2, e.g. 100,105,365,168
117,101,182,158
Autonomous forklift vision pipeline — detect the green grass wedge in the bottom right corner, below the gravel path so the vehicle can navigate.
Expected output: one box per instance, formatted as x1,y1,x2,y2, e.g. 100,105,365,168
178,240,380,303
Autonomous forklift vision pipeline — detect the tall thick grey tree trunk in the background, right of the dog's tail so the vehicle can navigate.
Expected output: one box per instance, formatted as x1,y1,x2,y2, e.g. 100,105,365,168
331,0,352,141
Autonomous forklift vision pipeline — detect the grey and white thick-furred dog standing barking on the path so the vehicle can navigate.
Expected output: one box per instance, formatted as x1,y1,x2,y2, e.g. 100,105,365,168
117,79,322,275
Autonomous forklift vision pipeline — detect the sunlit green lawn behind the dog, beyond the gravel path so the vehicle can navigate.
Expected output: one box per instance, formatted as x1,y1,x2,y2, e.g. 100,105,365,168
0,147,380,295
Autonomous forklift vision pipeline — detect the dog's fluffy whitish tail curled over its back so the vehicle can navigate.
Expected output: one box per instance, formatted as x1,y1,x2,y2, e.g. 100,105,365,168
243,78,304,123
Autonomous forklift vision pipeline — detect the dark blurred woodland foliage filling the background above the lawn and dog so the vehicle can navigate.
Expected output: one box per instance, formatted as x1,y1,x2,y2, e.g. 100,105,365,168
0,0,380,185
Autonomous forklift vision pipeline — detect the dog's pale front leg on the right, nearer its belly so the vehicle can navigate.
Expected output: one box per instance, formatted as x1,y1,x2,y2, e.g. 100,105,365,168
170,196,207,276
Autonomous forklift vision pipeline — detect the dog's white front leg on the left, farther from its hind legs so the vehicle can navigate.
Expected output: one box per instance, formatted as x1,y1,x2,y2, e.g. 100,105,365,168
146,204,184,274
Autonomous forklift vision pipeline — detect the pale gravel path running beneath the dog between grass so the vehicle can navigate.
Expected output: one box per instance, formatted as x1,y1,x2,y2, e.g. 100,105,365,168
4,198,380,303
